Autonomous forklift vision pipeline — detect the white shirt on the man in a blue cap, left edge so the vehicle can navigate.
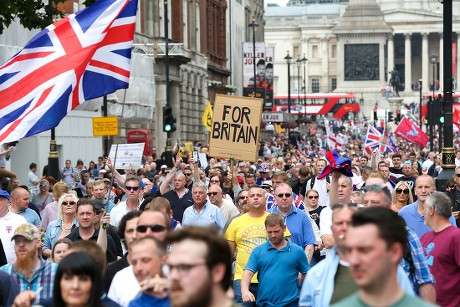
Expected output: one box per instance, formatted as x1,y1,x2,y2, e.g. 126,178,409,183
0,210,27,264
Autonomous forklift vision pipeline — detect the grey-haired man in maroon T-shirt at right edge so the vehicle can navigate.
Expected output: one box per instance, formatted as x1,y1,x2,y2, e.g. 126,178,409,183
420,192,460,306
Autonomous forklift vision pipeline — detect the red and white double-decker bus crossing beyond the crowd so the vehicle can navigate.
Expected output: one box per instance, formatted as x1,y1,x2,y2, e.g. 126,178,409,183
273,93,360,120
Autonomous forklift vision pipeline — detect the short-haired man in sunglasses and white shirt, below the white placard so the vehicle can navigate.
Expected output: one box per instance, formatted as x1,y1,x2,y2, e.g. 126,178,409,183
110,177,142,227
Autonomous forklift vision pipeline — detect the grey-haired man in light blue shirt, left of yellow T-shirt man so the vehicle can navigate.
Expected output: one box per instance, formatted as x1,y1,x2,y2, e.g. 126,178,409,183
182,181,225,230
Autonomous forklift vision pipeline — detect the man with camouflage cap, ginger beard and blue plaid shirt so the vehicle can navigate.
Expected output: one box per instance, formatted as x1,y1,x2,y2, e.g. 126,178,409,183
0,223,57,302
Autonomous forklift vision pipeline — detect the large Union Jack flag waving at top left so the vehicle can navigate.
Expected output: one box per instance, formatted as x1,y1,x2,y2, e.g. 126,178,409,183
0,0,137,144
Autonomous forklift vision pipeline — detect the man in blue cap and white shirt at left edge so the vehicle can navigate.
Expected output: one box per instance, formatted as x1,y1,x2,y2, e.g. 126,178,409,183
0,190,27,263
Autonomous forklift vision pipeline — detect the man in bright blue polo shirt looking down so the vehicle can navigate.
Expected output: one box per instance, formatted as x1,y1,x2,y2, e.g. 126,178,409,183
241,214,310,307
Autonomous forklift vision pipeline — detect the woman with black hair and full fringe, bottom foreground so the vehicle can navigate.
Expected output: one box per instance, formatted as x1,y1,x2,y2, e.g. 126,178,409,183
53,252,104,307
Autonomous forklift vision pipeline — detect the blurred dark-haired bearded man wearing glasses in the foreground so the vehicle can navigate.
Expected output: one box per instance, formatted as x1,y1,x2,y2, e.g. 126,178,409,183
167,227,234,307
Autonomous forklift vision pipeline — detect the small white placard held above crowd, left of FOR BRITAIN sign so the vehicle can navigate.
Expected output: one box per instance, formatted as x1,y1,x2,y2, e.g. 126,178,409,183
109,143,145,169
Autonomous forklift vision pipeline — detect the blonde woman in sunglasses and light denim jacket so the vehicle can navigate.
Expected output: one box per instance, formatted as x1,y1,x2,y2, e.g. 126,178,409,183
42,193,78,257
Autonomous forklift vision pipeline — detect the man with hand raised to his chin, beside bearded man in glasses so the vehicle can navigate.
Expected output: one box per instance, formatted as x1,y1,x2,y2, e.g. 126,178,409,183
128,236,170,307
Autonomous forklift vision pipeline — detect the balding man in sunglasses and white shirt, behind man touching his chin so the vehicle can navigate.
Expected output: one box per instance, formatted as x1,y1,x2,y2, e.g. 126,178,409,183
107,210,171,306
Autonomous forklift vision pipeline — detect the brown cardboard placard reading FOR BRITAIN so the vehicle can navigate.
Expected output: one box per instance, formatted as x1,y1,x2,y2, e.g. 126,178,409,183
209,95,263,162
